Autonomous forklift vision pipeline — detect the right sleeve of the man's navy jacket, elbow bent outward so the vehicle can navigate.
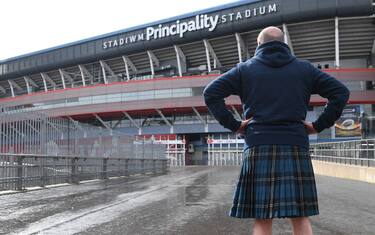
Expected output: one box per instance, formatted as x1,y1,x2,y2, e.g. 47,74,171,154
311,65,350,132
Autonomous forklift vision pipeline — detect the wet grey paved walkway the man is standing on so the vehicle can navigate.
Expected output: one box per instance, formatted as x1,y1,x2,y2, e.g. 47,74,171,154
0,167,375,235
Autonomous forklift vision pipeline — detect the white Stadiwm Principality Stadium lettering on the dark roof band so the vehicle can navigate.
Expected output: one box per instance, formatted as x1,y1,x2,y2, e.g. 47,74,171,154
103,3,278,49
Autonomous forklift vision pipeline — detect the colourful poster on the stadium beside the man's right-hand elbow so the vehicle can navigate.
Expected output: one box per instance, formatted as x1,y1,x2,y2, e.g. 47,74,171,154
335,105,362,138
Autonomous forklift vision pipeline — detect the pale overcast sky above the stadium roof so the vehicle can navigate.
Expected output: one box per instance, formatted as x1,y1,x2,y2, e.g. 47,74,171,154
0,0,235,60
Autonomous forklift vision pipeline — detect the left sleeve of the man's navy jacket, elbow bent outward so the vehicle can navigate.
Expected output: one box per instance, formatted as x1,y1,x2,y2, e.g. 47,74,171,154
203,65,241,132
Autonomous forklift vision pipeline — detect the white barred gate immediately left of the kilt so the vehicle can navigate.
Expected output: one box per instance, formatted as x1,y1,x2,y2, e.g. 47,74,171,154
207,134,244,166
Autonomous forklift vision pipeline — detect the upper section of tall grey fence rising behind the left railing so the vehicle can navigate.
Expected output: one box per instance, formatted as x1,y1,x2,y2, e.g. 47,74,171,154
0,110,147,157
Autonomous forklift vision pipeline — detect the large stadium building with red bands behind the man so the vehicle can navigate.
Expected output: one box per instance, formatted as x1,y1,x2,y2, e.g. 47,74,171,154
0,0,375,165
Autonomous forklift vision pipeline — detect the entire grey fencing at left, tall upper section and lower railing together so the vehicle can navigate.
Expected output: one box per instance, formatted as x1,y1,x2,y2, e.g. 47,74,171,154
0,110,169,190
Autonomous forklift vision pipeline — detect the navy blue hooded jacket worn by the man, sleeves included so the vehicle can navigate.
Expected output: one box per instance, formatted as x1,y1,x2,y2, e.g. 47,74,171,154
203,41,349,148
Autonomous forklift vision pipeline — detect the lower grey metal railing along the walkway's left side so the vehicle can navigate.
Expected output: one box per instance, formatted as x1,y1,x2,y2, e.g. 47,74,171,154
0,154,168,191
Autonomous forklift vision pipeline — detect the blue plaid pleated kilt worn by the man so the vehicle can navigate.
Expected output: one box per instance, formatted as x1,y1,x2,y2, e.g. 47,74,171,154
229,145,319,219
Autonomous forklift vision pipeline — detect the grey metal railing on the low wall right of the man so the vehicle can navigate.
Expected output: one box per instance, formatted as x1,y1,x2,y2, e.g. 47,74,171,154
310,139,375,167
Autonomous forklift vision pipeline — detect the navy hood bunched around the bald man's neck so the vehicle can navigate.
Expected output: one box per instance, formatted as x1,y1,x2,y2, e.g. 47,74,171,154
254,41,296,67
